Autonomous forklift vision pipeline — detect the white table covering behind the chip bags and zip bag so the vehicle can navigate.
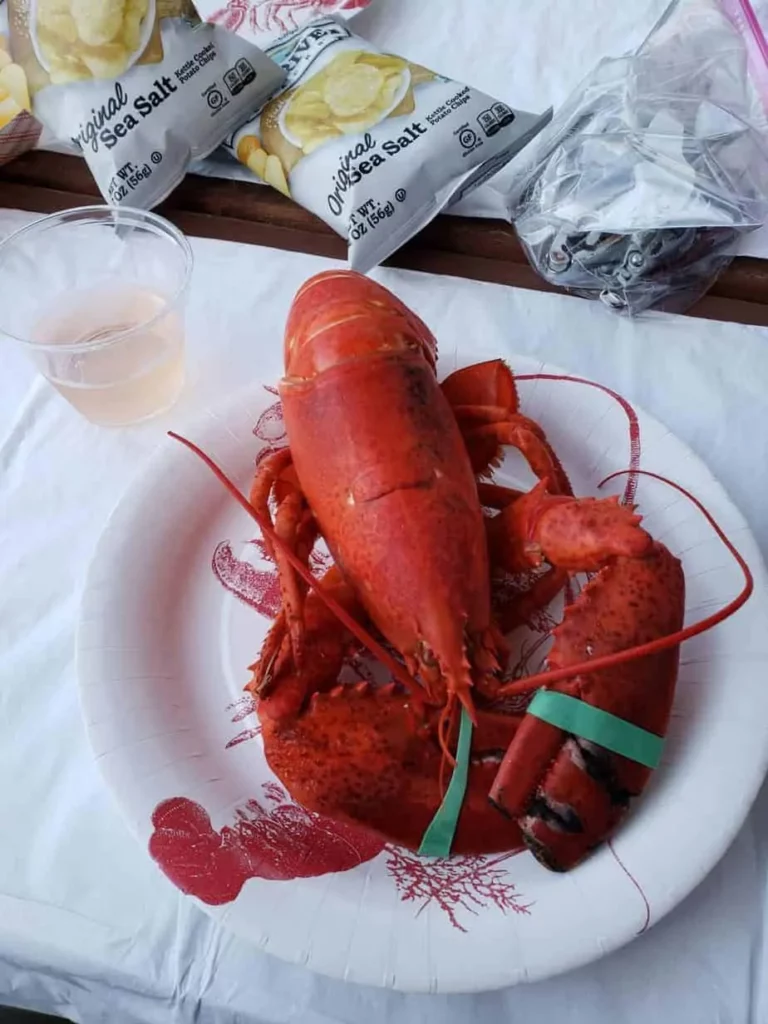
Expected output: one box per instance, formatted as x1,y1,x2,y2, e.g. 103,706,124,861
191,0,768,257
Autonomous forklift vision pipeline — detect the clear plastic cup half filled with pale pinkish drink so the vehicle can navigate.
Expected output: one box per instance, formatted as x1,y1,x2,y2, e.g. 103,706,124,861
0,206,193,426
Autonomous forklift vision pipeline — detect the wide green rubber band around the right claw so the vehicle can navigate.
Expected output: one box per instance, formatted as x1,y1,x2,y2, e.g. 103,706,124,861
528,690,664,768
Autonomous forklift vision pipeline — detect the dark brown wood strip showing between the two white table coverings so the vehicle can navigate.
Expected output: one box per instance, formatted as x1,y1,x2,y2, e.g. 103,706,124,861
6,152,768,326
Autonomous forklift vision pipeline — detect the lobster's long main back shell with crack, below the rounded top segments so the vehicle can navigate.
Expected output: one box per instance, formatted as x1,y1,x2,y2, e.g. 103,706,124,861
281,352,490,671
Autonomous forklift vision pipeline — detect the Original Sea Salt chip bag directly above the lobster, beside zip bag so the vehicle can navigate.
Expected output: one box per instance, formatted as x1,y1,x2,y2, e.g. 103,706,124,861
224,17,551,272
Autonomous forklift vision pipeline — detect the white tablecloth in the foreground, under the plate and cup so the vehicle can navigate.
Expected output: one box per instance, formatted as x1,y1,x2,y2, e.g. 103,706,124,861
0,201,768,1024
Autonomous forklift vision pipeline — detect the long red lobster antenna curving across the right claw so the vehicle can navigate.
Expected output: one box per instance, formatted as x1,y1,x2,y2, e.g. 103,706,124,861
499,469,755,696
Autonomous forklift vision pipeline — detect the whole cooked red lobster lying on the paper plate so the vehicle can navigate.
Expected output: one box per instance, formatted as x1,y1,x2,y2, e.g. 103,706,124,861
171,271,745,870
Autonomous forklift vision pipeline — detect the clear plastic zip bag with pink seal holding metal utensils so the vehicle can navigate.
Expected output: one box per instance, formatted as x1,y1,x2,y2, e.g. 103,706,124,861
512,0,768,314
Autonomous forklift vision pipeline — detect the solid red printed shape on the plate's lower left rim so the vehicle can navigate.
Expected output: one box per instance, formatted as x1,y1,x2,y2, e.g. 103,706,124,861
150,782,384,906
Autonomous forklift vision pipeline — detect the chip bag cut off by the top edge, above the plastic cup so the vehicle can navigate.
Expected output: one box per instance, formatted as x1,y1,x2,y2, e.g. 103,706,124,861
8,0,284,209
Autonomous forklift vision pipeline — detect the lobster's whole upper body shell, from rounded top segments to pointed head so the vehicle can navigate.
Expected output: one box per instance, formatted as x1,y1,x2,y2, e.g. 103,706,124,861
280,271,496,705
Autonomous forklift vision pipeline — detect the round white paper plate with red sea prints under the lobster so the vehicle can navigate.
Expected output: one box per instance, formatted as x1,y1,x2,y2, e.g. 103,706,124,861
78,357,768,992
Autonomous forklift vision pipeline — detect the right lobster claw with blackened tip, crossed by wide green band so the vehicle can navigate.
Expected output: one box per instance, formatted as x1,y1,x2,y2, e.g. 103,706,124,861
489,543,685,871
